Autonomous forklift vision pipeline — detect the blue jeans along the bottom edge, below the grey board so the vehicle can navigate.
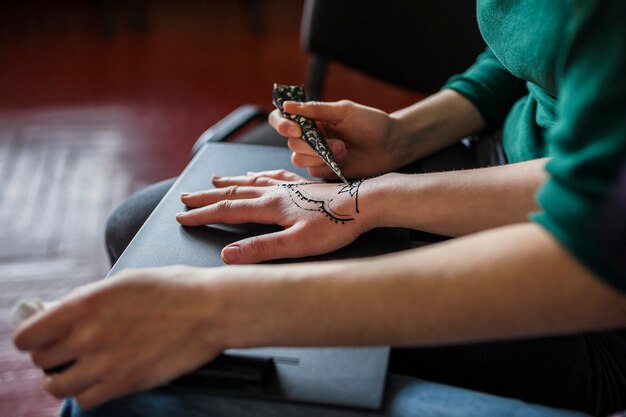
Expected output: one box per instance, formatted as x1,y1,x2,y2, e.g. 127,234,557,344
61,375,586,417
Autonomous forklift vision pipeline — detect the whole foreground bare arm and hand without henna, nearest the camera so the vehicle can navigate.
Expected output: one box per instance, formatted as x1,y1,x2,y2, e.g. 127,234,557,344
15,223,626,408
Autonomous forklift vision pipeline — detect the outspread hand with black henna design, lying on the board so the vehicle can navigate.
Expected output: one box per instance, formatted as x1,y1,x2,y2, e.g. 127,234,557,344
176,171,373,264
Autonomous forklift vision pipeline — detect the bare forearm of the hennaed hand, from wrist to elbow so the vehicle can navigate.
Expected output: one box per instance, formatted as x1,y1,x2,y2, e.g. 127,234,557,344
361,159,546,236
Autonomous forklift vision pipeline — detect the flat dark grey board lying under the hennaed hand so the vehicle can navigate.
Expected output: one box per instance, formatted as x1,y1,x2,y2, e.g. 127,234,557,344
109,143,408,408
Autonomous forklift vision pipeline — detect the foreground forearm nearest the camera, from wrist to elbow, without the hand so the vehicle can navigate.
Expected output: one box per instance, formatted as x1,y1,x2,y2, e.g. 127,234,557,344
217,223,626,347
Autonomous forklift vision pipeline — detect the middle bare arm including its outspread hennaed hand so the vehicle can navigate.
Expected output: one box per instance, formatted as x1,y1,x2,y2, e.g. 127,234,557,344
177,160,546,264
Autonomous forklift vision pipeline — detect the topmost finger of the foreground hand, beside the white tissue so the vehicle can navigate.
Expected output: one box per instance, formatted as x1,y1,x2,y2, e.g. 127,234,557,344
13,303,78,350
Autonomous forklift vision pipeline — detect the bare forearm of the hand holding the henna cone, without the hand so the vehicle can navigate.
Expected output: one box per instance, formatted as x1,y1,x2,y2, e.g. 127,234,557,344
390,90,485,163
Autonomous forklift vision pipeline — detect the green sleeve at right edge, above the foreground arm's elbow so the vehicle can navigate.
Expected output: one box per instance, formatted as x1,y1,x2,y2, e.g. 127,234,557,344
531,0,626,291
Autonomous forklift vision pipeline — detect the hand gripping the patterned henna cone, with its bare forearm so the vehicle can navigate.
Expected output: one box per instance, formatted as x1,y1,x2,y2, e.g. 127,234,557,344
269,90,485,178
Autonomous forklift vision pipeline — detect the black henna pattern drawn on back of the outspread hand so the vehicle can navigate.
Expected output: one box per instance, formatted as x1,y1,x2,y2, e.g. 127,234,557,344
278,180,364,224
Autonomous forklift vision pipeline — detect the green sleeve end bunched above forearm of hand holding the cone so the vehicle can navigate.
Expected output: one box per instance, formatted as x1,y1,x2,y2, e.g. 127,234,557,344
443,48,528,129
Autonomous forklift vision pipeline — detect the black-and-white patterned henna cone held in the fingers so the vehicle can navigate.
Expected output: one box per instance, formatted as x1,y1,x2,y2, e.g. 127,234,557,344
272,84,348,185
